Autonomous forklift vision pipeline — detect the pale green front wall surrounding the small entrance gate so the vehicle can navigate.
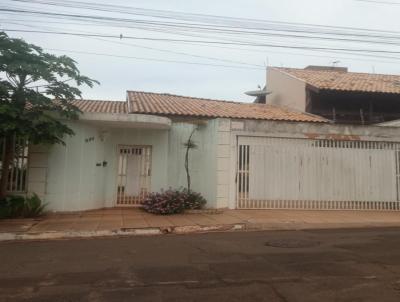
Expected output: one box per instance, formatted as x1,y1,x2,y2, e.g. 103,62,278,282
28,117,222,211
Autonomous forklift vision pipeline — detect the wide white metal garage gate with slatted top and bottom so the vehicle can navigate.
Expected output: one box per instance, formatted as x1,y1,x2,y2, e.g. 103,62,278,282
236,137,400,210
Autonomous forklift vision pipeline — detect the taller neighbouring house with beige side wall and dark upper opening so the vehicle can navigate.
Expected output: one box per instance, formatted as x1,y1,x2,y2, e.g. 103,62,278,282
263,66,400,125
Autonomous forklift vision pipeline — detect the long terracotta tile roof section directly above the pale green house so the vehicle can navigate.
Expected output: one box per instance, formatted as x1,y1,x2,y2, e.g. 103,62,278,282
128,91,327,122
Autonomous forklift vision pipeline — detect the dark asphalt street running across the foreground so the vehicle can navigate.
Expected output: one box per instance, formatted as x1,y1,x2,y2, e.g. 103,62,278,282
0,229,400,302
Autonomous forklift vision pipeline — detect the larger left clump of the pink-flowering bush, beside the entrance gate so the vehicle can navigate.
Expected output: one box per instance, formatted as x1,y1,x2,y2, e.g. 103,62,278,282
142,189,185,215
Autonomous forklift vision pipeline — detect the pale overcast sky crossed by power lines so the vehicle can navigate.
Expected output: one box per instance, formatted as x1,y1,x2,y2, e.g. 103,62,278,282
0,0,400,102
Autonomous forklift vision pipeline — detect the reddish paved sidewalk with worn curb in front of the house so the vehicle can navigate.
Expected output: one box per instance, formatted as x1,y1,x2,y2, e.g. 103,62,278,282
0,208,400,241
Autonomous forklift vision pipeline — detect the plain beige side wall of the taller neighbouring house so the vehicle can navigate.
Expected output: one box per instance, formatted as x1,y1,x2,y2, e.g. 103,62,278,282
266,67,306,111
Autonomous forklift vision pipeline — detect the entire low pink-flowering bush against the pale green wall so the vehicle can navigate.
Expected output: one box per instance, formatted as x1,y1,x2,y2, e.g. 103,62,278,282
142,189,206,215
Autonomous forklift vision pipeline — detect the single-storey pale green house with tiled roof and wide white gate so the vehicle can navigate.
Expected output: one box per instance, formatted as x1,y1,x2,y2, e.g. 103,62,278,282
6,91,400,211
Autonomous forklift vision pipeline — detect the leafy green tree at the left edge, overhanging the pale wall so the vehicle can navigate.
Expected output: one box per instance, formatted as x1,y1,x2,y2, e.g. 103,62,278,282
0,32,98,199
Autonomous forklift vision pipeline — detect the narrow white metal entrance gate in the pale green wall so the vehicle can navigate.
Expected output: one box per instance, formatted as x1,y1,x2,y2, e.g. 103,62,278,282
117,146,151,206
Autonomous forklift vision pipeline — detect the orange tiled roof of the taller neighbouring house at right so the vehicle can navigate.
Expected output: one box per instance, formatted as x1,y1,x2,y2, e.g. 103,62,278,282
274,68,400,94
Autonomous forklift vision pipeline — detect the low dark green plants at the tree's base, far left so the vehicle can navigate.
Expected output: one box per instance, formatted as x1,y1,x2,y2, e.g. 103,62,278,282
0,194,46,218
